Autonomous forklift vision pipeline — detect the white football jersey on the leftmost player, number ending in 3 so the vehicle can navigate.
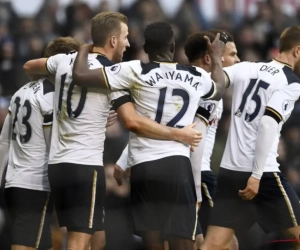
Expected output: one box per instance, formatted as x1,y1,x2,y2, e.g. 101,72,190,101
5,79,54,191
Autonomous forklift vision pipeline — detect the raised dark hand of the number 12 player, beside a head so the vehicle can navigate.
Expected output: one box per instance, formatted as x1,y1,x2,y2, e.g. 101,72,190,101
204,32,228,58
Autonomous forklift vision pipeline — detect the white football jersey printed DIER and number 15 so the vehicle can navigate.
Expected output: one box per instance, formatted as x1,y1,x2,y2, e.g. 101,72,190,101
221,60,300,172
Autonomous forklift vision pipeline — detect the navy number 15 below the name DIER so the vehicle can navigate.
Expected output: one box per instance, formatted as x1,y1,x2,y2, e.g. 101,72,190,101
235,79,270,122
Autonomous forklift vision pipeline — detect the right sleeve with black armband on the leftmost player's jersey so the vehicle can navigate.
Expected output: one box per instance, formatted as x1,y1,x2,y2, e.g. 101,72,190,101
39,79,54,126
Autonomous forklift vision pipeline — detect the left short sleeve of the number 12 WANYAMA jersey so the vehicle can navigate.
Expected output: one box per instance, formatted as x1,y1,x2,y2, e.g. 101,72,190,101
102,61,135,90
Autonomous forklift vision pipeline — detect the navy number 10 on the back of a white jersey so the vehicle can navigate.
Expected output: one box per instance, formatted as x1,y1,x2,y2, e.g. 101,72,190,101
57,73,87,118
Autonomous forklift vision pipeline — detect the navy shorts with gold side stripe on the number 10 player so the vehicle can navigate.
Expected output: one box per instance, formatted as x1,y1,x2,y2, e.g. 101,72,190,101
48,163,106,234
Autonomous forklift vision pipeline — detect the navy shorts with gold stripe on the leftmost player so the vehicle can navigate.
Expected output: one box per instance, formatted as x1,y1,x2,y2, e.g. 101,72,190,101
4,187,53,250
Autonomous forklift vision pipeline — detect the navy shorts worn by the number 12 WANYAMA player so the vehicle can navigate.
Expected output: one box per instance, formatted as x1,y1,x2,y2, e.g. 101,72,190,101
131,156,198,240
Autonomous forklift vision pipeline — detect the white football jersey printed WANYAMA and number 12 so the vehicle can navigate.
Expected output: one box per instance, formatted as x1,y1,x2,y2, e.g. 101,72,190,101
103,60,216,167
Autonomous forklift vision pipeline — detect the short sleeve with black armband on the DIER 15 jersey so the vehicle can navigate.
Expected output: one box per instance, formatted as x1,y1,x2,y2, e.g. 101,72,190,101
265,83,300,123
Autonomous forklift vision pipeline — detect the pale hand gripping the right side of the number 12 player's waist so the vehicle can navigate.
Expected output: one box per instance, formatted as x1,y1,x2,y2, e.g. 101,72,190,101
179,122,202,152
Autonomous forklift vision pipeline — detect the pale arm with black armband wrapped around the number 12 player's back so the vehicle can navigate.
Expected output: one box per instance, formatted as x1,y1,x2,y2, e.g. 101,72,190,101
112,91,201,146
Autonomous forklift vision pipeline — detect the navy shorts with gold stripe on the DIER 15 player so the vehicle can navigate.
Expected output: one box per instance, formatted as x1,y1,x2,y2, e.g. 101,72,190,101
209,168,300,233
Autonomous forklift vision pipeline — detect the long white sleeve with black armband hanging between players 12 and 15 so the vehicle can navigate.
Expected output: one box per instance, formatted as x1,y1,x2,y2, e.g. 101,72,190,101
196,100,223,171
